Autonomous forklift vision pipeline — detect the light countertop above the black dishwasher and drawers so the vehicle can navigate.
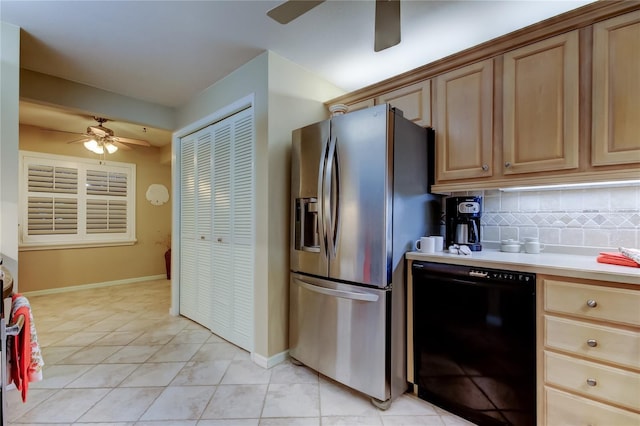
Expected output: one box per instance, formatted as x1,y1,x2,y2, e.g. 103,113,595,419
406,248,640,285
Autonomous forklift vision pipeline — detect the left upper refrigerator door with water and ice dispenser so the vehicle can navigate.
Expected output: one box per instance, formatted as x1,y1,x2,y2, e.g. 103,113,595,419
290,120,330,277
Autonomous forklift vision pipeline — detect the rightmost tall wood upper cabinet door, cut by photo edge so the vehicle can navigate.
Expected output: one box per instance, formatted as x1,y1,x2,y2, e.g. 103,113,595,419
591,11,640,166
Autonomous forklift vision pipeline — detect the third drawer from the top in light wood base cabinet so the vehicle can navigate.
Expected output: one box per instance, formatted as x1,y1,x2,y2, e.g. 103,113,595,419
544,351,640,411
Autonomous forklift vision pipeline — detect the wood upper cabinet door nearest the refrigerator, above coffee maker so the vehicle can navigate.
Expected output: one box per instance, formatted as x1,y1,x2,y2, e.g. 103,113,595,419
434,59,493,182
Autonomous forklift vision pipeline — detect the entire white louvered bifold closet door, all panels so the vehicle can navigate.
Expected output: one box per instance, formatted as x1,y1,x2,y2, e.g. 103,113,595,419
179,108,255,351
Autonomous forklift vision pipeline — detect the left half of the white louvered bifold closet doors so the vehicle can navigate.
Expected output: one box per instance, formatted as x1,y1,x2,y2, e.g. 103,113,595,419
180,128,212,327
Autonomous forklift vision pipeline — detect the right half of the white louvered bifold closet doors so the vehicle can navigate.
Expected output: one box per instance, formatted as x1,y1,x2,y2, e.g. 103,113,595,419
212,109,255,351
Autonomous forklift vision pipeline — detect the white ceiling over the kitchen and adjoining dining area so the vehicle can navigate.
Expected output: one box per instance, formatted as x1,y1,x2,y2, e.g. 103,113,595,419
0,0,592,145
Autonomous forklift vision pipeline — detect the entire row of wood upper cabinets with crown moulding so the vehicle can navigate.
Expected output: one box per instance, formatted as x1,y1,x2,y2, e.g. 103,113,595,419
327,1,640,193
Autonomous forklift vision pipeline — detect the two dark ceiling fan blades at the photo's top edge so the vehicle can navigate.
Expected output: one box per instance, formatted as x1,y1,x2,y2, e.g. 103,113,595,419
267,0,400,52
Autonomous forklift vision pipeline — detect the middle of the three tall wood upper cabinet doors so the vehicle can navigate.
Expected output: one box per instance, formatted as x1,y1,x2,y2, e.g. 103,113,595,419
503,30,580,175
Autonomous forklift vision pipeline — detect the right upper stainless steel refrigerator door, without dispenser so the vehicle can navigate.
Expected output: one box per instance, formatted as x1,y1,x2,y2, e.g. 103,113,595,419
329,105,392,288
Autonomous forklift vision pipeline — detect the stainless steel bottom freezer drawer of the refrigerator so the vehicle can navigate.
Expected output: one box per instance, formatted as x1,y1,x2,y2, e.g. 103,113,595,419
289,274,391,401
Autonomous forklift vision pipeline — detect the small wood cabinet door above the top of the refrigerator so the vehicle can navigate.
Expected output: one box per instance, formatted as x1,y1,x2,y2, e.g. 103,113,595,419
375,80,431,127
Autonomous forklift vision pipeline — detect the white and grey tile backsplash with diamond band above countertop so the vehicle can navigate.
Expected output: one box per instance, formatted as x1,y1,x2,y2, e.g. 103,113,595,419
452,186,640,249
